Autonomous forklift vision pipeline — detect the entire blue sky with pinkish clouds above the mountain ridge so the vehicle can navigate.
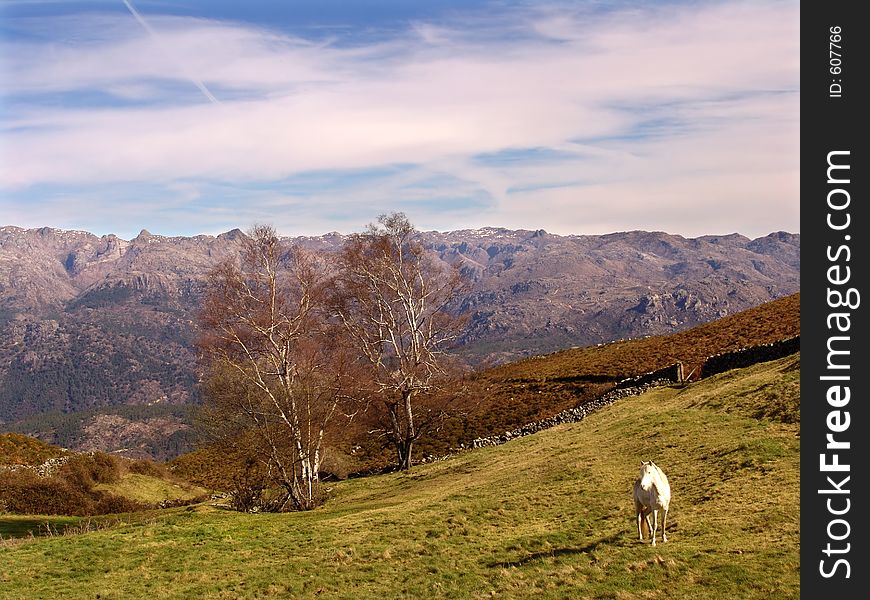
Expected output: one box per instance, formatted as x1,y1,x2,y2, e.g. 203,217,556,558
0,0,800,238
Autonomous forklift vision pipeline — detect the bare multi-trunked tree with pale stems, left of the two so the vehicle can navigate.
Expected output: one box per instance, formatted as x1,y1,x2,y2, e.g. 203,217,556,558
199,226,353,510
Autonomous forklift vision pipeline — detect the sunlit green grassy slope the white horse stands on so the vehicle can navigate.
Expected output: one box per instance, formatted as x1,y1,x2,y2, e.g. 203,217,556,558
0,355,800,600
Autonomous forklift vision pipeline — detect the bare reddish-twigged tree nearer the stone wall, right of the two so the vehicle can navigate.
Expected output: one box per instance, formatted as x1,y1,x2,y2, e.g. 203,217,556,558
337,213,470,470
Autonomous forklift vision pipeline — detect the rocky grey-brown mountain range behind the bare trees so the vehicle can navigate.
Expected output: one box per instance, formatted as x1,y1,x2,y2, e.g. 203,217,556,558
0,226,800,458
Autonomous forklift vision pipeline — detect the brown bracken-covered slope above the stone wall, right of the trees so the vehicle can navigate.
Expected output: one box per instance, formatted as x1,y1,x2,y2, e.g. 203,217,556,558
454,292,800,444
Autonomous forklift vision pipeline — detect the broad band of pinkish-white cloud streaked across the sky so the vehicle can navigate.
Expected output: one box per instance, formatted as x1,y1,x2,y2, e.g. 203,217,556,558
0,2,799,234
